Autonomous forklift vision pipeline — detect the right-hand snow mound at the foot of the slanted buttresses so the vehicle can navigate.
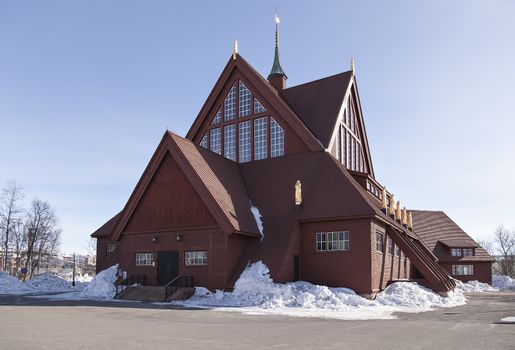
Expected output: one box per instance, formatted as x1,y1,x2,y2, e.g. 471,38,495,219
376,282,467,310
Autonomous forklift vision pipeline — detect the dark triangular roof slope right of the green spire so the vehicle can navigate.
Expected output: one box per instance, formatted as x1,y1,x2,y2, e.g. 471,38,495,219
281,71,352,148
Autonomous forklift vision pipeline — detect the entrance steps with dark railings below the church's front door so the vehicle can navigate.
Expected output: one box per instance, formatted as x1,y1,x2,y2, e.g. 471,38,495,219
117,286,195,302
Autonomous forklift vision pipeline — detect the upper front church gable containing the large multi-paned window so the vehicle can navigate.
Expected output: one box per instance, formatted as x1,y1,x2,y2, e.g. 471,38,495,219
187,55,320,163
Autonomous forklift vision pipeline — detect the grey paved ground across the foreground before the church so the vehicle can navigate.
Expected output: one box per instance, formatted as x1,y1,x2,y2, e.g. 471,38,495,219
0,293,515,350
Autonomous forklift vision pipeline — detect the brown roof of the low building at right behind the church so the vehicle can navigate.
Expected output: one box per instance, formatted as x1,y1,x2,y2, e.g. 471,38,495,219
412,210,493,261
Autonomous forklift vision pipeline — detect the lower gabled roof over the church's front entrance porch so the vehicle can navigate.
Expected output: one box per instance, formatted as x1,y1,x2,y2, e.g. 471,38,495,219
110,131,259,239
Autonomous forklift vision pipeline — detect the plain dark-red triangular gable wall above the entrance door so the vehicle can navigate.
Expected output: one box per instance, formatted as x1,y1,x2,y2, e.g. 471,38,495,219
123,152,217,232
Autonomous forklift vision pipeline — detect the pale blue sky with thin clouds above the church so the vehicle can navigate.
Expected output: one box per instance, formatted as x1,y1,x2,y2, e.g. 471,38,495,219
0,0,515,252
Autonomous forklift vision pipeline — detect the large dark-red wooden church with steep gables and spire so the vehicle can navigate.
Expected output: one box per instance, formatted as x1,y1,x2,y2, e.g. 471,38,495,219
92,21,491,297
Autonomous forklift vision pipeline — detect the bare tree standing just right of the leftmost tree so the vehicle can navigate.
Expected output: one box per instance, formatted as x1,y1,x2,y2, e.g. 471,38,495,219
25,199,61,277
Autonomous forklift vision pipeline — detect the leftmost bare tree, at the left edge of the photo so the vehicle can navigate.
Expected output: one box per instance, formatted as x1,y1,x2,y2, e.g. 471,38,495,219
0,181,24,270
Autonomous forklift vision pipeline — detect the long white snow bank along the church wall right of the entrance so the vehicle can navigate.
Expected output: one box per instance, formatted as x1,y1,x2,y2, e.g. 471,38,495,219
175,261,466,319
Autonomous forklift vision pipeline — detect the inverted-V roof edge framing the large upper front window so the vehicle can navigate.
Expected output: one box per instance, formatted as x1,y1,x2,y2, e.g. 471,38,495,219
186,54,324,151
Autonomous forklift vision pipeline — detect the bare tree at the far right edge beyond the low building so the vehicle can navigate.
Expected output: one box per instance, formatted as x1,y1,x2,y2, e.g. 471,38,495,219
494,226,515,277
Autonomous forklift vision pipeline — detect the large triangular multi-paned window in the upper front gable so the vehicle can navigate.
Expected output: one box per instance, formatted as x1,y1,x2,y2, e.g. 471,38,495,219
199,80,285,163
